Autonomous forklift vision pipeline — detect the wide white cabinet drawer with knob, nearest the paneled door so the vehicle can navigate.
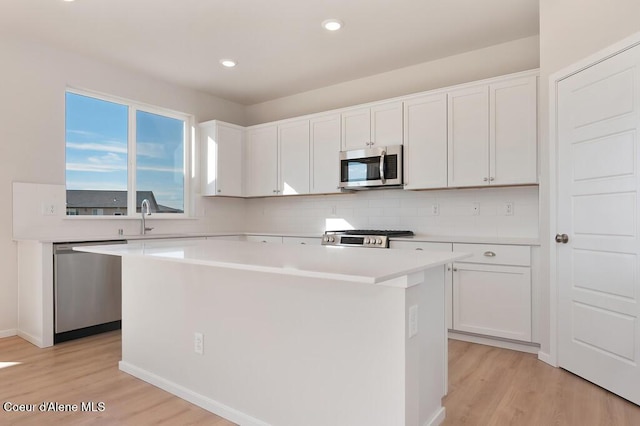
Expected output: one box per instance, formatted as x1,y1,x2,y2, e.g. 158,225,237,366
453,244,531,266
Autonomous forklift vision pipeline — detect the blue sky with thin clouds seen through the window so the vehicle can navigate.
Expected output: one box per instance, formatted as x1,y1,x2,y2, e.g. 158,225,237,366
66,92,184,210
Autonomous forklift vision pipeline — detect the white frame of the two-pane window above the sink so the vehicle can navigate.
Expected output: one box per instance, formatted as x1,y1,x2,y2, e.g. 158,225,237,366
64,86,195,220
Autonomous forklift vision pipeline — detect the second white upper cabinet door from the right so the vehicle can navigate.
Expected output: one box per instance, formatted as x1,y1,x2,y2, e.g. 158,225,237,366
448,86,489,187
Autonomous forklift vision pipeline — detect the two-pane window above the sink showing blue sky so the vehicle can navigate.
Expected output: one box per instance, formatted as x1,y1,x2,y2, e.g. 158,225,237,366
65,90,189,216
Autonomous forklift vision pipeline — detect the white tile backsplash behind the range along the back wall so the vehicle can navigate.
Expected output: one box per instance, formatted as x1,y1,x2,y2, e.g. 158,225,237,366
246,186,538,238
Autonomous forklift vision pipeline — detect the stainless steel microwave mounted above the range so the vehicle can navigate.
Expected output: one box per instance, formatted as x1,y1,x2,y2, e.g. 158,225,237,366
340,145,402,189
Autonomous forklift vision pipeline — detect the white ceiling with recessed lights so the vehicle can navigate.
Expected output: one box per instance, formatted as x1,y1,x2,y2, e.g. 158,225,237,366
0,0,538,105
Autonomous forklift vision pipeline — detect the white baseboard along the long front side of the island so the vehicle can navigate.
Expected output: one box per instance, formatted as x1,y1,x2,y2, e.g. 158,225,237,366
118,361,270,426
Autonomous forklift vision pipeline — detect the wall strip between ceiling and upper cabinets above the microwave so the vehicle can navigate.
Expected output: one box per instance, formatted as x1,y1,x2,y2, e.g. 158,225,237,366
247,36,539,124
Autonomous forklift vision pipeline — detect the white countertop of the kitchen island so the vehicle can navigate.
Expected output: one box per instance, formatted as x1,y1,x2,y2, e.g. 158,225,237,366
74,240,469,284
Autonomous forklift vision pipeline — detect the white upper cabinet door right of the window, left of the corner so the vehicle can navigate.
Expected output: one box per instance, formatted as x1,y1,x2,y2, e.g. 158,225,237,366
215,123,243,197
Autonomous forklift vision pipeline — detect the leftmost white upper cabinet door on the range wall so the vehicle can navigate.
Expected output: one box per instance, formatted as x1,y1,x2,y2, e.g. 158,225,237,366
247,125,278,197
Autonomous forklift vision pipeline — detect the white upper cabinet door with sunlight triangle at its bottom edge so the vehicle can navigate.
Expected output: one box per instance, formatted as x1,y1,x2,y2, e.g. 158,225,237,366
278,120,309,195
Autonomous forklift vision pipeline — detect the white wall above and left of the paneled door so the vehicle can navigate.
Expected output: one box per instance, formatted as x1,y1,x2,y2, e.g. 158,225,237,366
538,0,640,353
